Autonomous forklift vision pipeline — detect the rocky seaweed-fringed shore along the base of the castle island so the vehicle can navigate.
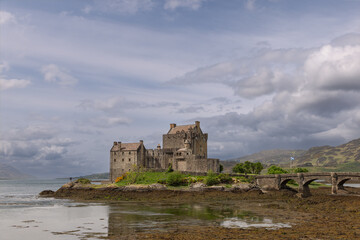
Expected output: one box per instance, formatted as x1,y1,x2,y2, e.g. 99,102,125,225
39,182,263,201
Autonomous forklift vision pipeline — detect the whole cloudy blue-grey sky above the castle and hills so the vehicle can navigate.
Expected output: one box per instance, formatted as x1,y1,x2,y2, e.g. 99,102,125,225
0,0,360,178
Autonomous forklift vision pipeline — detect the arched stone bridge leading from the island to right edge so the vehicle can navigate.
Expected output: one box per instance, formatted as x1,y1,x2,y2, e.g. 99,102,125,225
256,172,360,197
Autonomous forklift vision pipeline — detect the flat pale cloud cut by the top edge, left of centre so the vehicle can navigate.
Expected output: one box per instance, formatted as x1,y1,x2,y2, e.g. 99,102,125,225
89,0,154,14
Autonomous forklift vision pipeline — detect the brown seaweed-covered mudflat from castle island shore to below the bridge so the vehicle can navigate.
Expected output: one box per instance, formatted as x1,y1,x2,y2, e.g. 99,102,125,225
43,187,360,240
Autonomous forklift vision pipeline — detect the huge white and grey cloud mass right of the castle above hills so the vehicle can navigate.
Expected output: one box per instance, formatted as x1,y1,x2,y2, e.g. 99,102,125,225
172,34,360,158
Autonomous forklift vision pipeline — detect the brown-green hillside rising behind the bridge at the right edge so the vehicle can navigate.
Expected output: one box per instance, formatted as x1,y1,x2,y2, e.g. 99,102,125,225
295,139,360,167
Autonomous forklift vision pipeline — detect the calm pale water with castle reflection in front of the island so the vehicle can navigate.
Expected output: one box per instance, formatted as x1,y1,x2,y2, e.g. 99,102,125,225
0,180,290,240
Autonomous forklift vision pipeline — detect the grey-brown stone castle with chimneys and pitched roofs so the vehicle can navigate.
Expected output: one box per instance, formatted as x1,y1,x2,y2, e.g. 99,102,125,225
110,121,219,182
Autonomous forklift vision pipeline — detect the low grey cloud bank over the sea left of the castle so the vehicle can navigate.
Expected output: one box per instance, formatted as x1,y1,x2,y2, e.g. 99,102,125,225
0,125,87,178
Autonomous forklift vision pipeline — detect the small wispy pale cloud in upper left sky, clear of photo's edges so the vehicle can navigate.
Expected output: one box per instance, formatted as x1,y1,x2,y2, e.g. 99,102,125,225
41,64,78,86
